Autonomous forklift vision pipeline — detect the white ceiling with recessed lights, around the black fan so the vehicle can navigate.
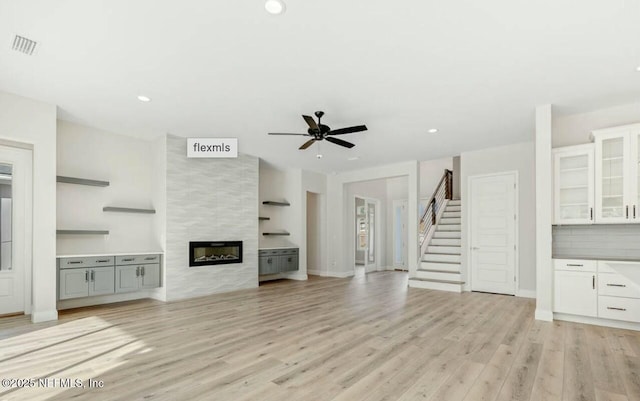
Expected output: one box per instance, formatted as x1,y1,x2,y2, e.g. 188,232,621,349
0,0,640,172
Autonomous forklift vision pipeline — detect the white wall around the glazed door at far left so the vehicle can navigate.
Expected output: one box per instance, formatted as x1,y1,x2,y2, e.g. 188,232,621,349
0,92,58,322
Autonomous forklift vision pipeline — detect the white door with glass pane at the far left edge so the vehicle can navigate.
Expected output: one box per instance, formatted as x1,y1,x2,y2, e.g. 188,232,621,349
0,146,32,315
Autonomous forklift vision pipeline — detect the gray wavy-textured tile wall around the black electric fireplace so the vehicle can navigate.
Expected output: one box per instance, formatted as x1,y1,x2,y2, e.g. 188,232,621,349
166,135,258,300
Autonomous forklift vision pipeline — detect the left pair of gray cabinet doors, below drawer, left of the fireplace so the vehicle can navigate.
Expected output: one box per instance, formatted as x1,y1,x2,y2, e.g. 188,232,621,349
60,266,114,299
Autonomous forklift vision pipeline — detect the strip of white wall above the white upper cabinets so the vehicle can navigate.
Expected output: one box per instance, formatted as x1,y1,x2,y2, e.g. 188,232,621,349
552,103,640,148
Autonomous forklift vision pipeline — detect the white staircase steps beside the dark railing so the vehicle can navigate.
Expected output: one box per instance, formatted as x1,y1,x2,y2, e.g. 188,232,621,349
409,199,464,292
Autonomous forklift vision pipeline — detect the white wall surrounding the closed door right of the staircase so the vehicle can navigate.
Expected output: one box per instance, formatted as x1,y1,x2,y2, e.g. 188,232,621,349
460,142,536,297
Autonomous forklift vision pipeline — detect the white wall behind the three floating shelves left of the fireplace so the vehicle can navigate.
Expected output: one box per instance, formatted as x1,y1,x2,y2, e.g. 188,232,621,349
57,121,163,255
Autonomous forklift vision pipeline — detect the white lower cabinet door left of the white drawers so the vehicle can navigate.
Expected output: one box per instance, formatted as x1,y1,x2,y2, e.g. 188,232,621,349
553,270,598,317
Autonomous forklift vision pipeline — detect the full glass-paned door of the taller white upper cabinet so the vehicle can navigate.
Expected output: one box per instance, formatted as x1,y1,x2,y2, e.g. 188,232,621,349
596,132,631,223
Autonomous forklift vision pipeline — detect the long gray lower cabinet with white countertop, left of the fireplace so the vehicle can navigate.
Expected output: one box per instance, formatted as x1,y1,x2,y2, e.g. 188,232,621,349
58,254,161,300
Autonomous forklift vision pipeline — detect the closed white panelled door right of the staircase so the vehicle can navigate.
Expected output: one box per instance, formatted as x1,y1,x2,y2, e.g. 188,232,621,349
469,172,518,295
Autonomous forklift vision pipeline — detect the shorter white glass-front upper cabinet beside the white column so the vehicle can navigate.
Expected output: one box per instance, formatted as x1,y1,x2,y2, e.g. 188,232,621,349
553,144,595,224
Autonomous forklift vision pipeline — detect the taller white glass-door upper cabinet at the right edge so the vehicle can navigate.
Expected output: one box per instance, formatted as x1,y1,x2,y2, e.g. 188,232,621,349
593,124,640,223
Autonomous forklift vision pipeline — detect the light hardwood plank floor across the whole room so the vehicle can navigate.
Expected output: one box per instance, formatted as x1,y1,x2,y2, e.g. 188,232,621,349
0,272,640,401
